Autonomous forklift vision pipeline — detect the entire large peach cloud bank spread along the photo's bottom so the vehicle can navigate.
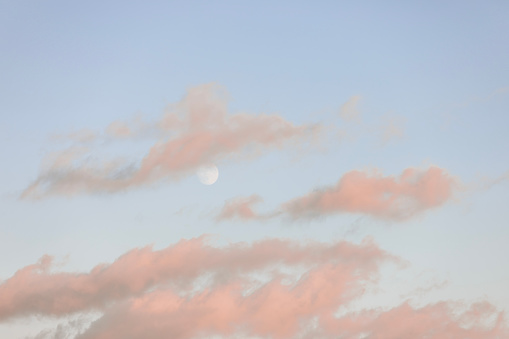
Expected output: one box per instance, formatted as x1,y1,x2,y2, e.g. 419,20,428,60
0,238,509,339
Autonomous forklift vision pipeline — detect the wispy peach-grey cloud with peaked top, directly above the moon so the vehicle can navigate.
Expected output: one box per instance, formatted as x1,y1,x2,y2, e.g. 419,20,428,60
21,84,320,199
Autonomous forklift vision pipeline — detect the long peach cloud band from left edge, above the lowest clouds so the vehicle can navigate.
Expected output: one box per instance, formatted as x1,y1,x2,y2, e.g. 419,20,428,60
0,238,384,321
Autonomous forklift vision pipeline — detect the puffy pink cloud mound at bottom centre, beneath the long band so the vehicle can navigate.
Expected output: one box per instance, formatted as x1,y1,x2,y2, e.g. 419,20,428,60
76,264,372,339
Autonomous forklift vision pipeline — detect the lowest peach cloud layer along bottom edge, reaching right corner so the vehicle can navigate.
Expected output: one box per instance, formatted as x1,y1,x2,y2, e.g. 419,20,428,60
73,292,509,339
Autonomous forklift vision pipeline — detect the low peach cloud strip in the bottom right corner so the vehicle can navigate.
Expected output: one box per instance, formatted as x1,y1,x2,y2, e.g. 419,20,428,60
323,302,509,339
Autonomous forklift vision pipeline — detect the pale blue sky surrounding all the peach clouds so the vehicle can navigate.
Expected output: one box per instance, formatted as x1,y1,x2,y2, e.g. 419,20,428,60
0,1,509,338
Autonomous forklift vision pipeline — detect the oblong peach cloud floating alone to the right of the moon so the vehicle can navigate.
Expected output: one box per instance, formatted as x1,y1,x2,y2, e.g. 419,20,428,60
281,166,457,220
